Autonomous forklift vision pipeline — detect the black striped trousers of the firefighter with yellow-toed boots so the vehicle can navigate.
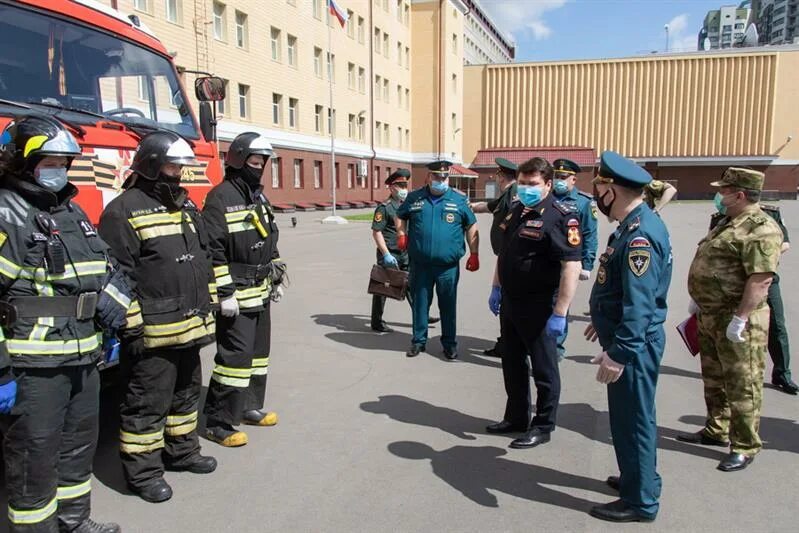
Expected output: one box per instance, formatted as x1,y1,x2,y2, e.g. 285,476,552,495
203,301,272,427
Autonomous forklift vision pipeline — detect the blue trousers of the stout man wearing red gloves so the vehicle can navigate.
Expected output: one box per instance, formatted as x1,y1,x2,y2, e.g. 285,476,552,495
409,261,460,350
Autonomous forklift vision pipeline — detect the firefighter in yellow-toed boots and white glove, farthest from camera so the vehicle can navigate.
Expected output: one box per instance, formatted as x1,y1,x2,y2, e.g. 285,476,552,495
203,132,286,447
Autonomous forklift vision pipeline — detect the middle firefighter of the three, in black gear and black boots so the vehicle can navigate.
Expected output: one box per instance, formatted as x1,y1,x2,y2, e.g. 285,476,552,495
100,131,216,503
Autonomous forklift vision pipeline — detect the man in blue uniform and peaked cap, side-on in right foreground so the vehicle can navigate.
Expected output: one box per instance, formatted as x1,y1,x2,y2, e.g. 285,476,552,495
586,151,672,522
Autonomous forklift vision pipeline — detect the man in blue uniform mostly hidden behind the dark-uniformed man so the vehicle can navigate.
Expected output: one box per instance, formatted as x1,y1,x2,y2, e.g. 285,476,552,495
552,159,598,360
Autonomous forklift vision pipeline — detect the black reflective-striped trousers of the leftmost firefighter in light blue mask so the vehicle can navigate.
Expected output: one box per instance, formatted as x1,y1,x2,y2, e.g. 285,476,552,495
0,363,100,533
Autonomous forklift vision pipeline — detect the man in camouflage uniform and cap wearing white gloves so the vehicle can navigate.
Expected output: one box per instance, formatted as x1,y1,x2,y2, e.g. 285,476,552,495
677,167,782,472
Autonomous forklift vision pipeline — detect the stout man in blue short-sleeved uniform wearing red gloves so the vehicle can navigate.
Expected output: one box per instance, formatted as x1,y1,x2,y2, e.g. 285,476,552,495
397,161,480,360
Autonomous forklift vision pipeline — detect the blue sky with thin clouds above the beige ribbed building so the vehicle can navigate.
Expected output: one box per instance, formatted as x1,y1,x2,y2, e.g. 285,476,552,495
480,0,740,61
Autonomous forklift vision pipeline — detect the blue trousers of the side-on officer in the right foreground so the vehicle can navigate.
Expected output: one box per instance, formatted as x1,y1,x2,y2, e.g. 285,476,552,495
608,327,666,515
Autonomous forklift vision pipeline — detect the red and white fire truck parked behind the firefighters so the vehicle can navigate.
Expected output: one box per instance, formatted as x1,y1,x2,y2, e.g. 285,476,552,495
0,0,225,223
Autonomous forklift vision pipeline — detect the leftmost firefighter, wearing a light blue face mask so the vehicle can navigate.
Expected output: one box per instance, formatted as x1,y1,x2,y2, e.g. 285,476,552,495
0,115,130,533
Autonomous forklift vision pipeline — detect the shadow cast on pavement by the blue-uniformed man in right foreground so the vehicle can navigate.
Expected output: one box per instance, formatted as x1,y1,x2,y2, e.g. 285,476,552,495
388,441,614,512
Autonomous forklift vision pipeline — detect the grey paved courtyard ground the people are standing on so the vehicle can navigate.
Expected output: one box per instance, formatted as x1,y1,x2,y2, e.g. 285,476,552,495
0,202,799,533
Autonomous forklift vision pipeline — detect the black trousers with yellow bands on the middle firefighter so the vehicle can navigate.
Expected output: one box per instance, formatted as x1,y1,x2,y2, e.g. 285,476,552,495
119,346,202,488
